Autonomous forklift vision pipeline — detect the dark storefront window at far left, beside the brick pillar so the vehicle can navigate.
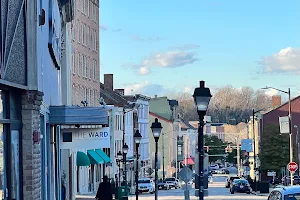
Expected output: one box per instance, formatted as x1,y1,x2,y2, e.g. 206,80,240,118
0,86,22,199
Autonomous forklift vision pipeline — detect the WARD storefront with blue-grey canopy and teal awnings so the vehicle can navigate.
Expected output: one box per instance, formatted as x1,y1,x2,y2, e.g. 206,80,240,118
50,106,111,199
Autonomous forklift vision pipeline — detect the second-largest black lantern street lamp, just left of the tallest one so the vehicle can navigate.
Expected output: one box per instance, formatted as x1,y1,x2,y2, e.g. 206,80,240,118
151,118,162,200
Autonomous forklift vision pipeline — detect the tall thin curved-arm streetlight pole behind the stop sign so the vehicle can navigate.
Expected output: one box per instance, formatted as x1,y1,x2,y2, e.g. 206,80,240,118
262,86,294,185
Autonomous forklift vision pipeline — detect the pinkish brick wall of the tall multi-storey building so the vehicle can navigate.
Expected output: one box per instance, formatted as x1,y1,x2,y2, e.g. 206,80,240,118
70,0,100,106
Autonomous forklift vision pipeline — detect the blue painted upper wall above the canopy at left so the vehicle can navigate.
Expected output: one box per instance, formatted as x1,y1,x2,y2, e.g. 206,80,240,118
36,0,63,105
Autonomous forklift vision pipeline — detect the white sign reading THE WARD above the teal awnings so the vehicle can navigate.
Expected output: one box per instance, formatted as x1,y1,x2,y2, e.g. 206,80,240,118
60,127,110,149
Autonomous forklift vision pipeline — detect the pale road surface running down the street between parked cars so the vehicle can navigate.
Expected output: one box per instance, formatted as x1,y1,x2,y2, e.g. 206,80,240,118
128,176,267,200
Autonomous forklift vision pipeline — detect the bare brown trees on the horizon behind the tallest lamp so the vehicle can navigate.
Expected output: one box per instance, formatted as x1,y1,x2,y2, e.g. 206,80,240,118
170,85,271,124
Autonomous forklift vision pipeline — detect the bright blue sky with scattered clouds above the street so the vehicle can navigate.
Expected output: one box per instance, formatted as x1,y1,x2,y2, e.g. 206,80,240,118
100,0,300,96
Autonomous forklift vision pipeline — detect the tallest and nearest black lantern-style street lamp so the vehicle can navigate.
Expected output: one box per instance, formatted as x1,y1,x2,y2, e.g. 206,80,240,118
193,81,212,200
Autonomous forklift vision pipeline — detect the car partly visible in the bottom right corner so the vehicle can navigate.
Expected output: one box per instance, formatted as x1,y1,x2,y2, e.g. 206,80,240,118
268,185,300,200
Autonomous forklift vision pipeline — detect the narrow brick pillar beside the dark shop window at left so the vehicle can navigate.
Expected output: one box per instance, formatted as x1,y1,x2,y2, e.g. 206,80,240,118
22,91,43,200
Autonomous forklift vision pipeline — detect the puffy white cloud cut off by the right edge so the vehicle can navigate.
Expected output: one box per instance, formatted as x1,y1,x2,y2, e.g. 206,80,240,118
259,47,300,73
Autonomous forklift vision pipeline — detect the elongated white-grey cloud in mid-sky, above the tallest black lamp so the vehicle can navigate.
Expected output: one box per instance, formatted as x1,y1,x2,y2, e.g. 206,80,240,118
132,51,199,75
